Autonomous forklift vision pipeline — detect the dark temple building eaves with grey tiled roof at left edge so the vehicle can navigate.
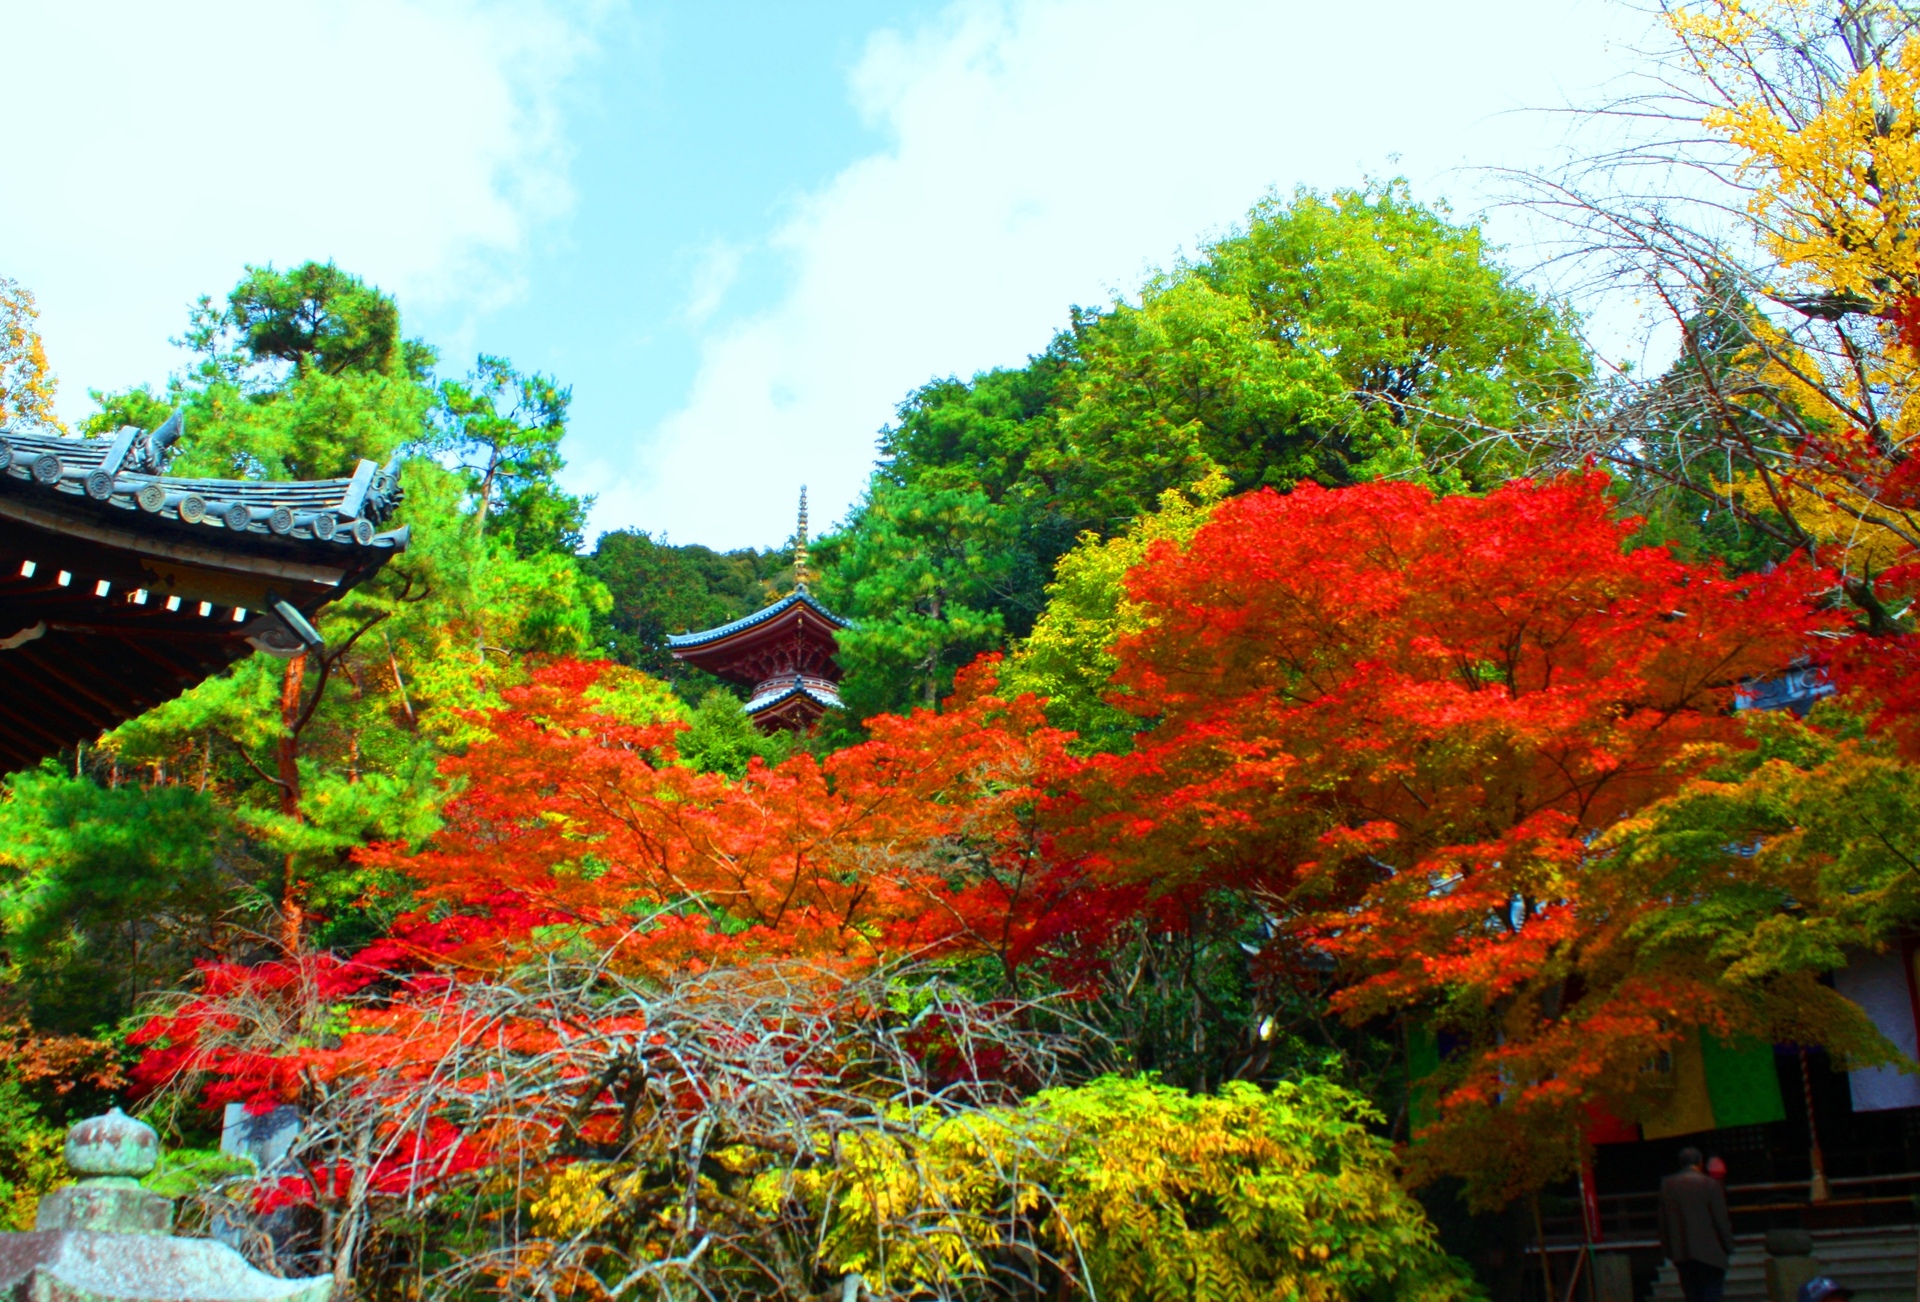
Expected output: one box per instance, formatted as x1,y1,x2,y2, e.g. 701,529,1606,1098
0,413,407,772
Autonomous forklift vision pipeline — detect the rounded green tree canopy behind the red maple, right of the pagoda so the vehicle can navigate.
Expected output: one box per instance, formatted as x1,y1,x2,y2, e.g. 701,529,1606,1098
818,181,1588,729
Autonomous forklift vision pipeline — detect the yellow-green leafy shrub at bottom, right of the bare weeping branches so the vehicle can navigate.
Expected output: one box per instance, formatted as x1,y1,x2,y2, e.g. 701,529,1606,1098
758,1077,1475,1302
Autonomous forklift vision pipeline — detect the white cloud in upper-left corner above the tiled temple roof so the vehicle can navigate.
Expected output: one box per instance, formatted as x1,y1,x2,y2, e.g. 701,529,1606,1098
0,0,597,415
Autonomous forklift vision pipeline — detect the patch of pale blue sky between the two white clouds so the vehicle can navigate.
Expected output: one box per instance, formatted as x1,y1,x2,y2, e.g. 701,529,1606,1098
439,0,939,533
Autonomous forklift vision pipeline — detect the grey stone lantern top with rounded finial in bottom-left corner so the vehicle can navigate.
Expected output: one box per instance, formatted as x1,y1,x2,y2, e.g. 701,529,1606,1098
0,1108,334,1302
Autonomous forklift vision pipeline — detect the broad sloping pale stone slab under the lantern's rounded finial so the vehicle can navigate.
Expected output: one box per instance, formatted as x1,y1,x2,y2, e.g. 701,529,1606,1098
0,1229,334,1302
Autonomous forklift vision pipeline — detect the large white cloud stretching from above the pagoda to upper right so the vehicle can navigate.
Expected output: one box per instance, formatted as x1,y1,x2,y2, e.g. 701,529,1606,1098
595,0,1644,545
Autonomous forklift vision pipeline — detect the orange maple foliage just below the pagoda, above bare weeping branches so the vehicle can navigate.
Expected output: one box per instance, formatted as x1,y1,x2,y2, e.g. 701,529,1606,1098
363,661,1066,972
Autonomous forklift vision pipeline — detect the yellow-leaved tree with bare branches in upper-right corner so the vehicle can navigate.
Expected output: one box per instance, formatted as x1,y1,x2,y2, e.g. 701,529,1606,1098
1490,0,1920,591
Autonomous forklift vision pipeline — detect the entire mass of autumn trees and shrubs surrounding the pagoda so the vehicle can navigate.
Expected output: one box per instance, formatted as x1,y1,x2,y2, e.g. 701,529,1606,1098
0,0,1920,1302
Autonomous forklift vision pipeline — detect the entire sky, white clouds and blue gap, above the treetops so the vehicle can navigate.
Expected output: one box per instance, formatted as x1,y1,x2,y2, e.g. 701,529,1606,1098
0,0,1645,547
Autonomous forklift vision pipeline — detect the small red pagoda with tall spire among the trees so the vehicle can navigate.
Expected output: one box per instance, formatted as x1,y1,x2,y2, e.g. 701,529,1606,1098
666,488,852,732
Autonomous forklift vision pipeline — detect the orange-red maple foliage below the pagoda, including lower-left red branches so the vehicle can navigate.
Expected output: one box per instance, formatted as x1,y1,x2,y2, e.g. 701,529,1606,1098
134,661,1071,1106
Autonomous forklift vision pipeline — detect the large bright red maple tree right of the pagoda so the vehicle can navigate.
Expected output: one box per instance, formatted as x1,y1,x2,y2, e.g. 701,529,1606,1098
1066,474,1830,1200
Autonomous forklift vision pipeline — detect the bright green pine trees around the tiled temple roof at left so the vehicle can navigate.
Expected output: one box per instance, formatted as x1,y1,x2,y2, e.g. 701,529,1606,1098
39,263,607,979
